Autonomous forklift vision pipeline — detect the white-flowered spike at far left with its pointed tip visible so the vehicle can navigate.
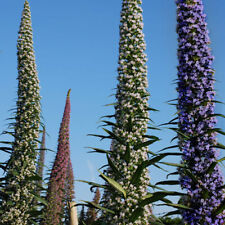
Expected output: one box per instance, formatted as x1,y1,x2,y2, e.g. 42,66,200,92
0,1,40,225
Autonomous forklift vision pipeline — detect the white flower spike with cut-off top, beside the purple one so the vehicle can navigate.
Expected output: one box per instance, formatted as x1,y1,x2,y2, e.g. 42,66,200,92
103,0,151,225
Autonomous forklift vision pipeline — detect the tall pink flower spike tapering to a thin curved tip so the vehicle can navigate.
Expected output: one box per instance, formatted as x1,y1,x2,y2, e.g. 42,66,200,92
44,90,70,225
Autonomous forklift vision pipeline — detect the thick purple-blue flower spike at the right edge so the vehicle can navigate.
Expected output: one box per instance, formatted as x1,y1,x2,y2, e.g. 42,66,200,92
176,0,225,225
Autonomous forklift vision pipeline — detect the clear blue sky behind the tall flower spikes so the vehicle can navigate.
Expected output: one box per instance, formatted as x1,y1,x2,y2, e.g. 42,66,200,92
0,0,225,216
